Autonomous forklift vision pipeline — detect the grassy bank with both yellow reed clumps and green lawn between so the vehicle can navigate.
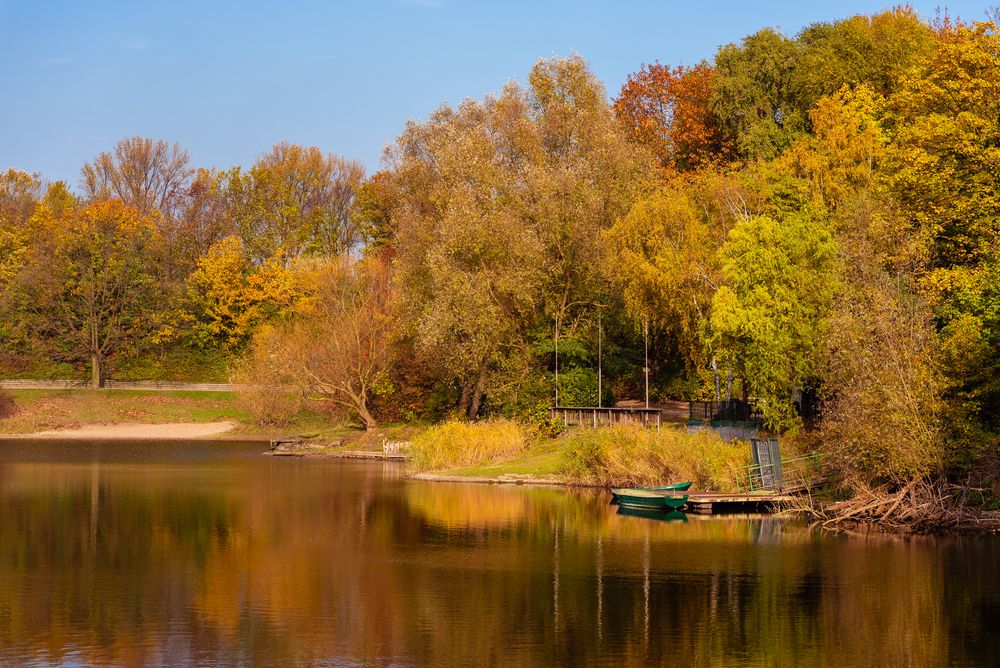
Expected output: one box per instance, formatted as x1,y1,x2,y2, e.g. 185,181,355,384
411,420,750,491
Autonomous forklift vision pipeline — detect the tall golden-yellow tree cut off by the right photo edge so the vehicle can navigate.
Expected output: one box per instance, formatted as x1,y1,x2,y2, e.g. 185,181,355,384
885,20,1000,460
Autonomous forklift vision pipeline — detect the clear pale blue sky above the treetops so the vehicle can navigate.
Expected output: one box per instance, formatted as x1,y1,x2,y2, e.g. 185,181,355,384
0,0,1000,186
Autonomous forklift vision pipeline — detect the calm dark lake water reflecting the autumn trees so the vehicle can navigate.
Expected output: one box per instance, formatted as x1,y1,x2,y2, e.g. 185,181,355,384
0,442,1000,666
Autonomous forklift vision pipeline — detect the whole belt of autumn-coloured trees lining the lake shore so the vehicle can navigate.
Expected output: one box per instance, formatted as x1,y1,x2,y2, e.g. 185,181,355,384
0,8,1000,484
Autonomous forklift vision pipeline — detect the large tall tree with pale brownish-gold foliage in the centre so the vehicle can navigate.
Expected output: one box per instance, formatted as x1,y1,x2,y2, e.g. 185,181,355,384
389,57,652,419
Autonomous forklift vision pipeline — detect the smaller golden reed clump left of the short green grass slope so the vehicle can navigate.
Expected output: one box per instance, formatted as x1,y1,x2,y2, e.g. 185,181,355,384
410,420,530,471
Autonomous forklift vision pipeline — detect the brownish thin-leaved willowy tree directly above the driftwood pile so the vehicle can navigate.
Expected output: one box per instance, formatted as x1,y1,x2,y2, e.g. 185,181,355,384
821,264,946,489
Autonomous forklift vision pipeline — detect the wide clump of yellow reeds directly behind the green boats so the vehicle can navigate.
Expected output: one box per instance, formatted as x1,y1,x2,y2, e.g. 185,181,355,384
564,425,751,492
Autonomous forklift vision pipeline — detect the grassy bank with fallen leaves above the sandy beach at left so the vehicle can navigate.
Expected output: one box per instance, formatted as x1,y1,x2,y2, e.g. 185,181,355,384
0,389,344,437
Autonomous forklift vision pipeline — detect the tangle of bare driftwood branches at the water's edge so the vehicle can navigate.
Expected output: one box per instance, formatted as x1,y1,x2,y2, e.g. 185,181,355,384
789,478,996,533
